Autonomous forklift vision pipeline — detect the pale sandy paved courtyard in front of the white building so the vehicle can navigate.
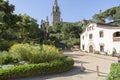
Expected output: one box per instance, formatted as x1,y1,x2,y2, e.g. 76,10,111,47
16,51,117,80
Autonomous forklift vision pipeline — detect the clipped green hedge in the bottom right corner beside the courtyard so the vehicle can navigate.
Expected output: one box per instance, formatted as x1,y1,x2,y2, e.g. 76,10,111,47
107,63,120,80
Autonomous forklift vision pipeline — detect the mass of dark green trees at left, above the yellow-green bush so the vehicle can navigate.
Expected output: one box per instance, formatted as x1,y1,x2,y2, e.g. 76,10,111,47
0,0,42,51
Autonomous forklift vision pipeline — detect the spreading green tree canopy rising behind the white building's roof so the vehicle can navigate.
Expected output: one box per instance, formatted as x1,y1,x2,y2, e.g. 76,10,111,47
93,6,120,26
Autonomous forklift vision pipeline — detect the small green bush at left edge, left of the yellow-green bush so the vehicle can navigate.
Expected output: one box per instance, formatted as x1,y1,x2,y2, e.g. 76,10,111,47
0,51,14,65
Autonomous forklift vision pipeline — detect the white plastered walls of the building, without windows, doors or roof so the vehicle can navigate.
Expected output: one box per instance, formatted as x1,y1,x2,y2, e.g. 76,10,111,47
80,23,120,54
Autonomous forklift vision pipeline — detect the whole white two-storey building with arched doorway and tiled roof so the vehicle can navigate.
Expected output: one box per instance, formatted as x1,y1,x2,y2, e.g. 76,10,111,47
80,23,120,54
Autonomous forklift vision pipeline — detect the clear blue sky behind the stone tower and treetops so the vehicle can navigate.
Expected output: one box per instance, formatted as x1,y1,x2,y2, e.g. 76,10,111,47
9,0,120,24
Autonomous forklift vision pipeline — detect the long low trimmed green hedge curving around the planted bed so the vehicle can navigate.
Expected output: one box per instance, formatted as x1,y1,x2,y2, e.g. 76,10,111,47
0,57,74,80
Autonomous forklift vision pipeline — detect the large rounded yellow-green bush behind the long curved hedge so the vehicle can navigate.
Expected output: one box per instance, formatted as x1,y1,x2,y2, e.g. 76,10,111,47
9,44,60,63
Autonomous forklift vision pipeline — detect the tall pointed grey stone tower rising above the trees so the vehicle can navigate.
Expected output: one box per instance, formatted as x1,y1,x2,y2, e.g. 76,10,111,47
51,0,61,25
